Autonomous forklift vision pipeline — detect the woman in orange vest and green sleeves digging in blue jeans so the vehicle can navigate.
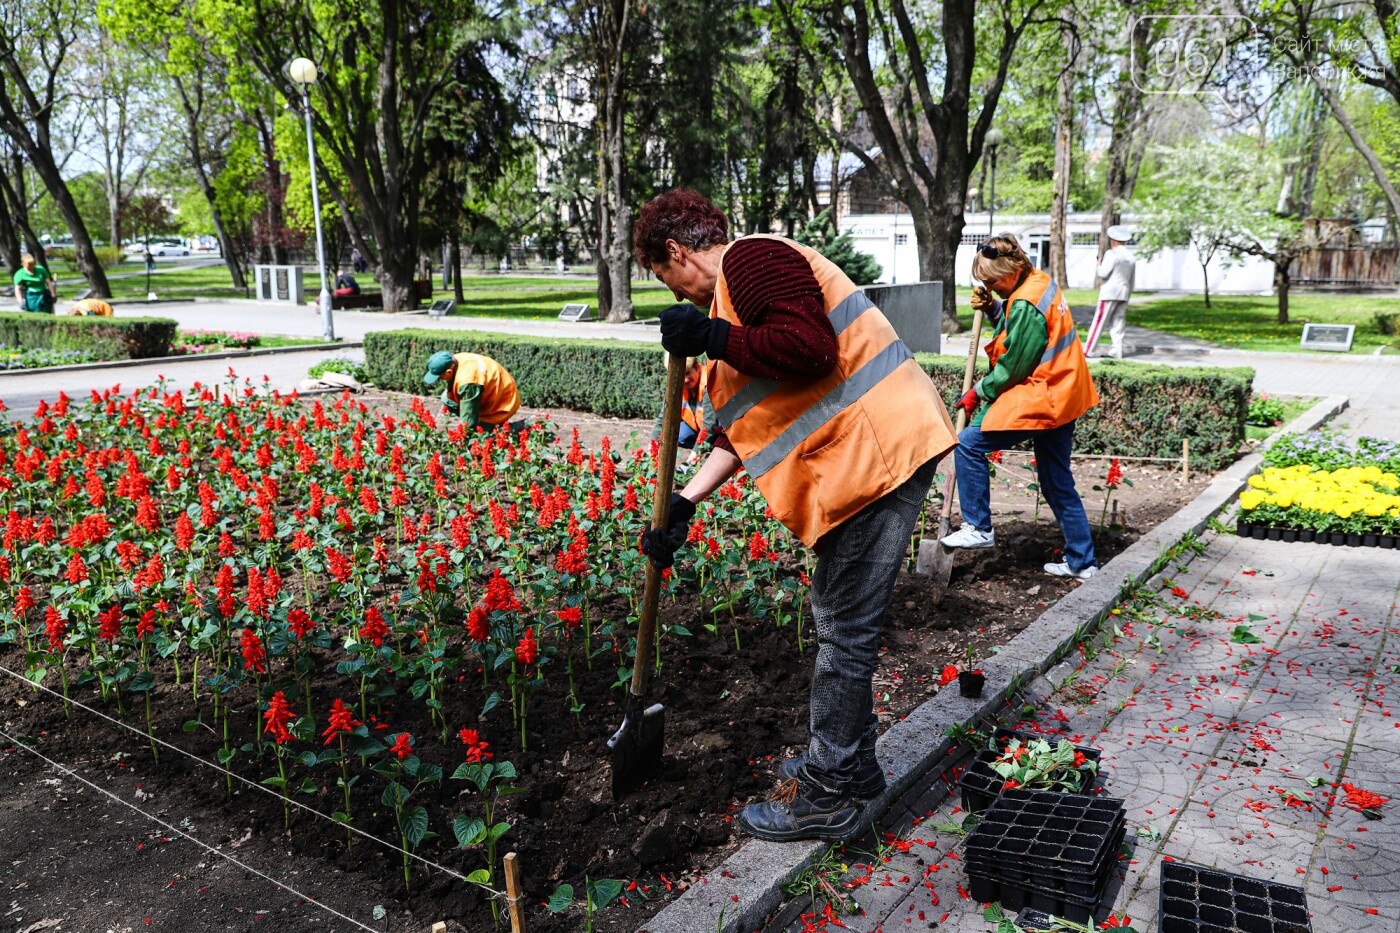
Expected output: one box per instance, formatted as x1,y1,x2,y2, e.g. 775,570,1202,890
942,234,1099,580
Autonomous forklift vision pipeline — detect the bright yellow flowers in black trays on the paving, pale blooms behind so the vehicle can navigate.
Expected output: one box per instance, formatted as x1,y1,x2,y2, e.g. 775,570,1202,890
1238,434,1400,548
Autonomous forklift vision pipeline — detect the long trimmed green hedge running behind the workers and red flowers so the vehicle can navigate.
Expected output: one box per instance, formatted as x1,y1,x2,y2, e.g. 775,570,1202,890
364,331,1254,469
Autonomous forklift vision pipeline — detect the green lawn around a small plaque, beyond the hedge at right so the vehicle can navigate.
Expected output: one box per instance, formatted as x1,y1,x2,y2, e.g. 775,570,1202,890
1128,293,1400,353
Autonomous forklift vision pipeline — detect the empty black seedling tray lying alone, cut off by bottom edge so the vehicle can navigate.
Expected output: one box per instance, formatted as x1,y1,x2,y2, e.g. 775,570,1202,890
1158,862,1312,933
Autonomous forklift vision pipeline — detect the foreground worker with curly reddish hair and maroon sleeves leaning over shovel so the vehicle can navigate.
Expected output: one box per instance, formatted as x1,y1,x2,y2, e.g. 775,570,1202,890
633,189,956,841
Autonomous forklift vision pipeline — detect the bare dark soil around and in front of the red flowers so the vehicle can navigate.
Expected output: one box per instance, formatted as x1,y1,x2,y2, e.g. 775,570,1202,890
0,392,1208,933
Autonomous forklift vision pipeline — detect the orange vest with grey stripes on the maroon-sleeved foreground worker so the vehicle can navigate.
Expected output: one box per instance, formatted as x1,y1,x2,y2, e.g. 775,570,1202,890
708,237,958,546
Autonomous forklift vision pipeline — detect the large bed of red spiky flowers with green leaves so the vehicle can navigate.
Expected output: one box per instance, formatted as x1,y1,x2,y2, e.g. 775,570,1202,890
0,384,1204,930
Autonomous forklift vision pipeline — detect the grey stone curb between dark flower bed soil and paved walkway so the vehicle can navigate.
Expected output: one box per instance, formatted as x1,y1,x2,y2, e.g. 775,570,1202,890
637,395,1348,933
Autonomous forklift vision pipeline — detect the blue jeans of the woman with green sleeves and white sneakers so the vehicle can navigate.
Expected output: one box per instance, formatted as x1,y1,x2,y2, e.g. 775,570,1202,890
955,422,1099,570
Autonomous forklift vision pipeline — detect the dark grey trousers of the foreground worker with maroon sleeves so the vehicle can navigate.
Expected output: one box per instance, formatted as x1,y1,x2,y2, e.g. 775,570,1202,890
806,458,938,792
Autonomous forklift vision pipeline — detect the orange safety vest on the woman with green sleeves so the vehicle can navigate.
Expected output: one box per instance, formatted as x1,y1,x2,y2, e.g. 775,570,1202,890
981,269,1099,431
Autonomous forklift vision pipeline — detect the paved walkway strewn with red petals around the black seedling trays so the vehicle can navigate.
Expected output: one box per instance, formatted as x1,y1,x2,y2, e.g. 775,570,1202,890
770,534,1400,933
